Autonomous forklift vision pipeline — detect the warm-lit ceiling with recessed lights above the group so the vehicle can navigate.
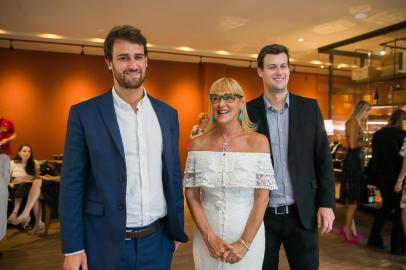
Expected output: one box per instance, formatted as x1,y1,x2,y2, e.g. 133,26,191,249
0,0,406,74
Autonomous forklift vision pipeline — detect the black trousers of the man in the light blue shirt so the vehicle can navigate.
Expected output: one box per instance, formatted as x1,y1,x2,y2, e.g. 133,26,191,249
262,207,319,270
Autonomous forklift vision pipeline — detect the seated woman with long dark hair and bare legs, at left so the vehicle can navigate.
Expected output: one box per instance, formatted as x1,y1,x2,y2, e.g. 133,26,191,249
7,144,44,233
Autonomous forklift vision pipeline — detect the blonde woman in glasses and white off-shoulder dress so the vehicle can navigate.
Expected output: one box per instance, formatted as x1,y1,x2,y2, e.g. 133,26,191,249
185,78,276,270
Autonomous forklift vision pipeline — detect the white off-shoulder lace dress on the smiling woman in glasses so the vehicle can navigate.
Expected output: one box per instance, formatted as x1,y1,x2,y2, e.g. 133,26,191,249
185,151,277,270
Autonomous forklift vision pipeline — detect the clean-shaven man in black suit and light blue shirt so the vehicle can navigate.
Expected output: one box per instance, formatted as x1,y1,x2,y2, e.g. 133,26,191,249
247,44,335,270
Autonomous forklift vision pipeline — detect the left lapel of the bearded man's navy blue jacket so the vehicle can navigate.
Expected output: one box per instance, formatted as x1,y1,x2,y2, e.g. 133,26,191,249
98,90,125,161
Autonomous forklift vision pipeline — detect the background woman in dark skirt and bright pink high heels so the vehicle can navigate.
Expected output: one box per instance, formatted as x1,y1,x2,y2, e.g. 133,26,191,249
340,101,371,244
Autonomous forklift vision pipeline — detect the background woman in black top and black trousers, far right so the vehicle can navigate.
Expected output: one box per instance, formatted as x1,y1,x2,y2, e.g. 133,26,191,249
368,110,406,254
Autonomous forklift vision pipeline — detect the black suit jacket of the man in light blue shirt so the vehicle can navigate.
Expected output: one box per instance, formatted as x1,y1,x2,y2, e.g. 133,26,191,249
247,93,335,229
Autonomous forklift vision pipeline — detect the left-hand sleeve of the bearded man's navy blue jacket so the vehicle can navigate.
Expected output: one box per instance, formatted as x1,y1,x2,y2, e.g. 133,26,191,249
59,106,89,254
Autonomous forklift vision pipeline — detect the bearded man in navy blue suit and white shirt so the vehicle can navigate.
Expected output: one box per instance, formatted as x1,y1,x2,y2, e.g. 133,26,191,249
60,26,188,270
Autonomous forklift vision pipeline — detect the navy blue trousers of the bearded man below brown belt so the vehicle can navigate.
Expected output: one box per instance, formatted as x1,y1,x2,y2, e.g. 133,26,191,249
115,223,175,270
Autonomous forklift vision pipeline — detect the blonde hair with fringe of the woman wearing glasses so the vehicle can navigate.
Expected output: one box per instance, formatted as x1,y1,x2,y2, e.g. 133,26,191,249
207,78,257,131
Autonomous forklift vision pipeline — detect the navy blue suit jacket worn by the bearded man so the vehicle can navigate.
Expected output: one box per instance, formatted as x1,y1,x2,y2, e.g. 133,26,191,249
60,90,188,269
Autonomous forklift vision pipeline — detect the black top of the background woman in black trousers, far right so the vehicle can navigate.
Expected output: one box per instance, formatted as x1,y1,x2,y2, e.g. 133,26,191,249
368,127,405,186
